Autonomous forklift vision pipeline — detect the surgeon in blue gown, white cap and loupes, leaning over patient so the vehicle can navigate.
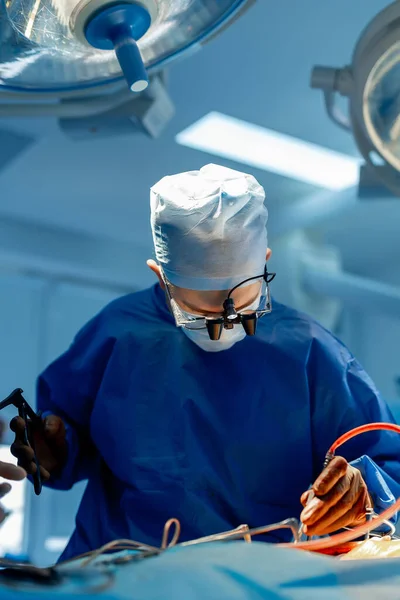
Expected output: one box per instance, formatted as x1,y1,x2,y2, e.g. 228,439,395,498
12,165,400,559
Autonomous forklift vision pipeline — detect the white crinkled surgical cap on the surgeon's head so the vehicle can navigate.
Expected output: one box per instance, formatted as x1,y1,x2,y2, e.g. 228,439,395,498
150,164,268,291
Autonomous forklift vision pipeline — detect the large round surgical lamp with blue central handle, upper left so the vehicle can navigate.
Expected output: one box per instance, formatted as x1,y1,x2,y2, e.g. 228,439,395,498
0,0,254,118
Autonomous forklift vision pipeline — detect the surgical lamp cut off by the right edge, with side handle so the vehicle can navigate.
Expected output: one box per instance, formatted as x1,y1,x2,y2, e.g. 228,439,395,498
311,1,400,196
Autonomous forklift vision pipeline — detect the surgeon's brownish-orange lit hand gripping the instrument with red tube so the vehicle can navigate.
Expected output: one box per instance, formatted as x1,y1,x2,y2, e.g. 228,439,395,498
300,456,372,537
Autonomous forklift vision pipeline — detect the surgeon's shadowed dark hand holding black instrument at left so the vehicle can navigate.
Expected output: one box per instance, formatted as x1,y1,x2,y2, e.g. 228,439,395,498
10,415,67,481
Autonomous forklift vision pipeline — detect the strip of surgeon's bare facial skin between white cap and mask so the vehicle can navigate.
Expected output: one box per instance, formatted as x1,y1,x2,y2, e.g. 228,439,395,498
171,281,261,313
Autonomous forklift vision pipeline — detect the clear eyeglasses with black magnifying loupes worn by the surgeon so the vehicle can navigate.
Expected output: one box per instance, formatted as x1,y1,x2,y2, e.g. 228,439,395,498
163,266,276,341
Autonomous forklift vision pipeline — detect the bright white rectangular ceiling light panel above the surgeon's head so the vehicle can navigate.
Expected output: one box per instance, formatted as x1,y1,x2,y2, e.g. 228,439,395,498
176,112,361,190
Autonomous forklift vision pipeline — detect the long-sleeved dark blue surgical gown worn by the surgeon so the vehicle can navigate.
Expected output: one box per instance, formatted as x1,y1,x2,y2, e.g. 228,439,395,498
38,285,400,559
